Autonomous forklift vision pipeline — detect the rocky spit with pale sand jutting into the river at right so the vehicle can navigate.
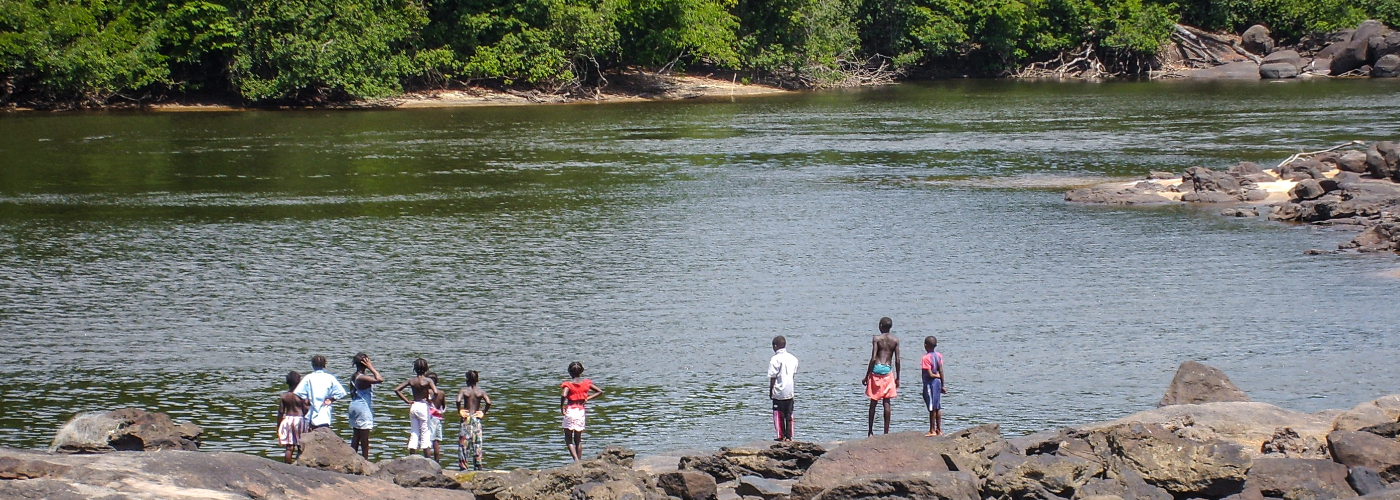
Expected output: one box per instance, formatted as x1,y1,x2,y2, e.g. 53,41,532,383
1064,141,1400,254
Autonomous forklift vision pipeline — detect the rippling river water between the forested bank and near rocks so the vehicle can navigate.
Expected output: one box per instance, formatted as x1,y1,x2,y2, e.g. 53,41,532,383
0,80,1400,466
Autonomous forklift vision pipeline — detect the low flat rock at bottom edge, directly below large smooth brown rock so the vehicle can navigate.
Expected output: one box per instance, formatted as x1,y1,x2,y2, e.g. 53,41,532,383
815,472,981,500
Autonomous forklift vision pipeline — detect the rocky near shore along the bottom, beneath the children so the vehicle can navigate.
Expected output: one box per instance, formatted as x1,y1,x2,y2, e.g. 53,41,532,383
0,361,1400,500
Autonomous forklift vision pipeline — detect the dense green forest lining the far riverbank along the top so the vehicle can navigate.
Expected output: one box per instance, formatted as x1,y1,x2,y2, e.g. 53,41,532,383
0,0,1400,105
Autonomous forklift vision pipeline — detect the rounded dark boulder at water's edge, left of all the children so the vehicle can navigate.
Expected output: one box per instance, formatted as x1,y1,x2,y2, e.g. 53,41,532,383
49,408,203,452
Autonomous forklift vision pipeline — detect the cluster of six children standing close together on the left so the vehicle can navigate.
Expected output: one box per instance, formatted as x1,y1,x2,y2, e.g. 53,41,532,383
277,353,501,471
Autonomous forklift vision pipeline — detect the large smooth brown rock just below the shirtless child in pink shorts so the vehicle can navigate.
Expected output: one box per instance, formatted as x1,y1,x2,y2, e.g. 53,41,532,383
792,424,1011,500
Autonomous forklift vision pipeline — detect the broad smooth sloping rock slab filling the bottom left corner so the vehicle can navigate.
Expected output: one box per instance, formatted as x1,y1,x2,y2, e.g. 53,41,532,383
0,448,473,500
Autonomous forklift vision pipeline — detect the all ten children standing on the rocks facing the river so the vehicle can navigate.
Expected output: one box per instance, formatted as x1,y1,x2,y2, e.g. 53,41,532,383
277,318,948,471
